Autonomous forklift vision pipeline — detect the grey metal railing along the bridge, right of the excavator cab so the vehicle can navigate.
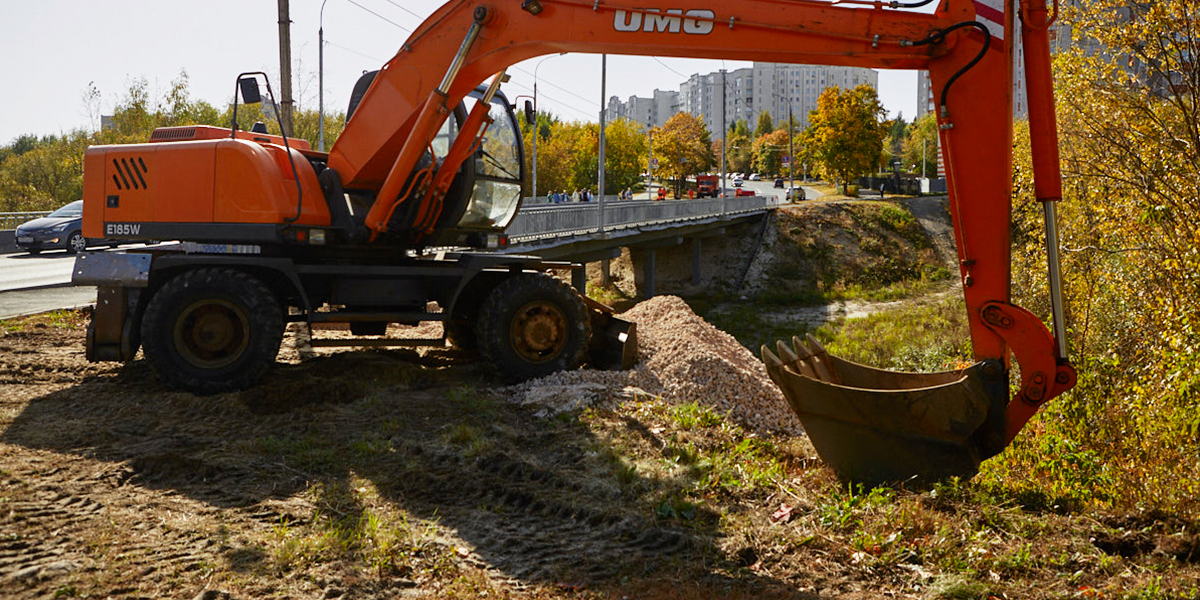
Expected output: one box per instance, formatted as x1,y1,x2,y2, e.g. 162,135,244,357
506,196,778,242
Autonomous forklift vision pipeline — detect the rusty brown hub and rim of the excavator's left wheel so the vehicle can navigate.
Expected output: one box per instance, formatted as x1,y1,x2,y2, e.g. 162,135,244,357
174,299,250,368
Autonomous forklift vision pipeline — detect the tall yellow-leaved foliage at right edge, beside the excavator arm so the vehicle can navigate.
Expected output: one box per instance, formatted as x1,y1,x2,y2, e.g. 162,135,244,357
984,0,1200,513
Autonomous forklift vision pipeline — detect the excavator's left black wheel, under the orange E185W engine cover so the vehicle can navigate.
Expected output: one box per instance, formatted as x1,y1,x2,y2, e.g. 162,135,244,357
142,269,283,394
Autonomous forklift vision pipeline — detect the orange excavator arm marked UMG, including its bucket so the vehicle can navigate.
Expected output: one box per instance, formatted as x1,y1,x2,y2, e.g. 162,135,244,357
329,0,1075,482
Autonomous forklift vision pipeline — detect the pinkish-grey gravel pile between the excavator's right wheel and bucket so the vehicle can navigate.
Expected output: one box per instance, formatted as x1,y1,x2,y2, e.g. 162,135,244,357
504,296,804,434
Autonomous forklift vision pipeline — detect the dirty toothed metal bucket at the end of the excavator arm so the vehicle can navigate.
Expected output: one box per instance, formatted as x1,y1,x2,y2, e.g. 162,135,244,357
762,336,1008,486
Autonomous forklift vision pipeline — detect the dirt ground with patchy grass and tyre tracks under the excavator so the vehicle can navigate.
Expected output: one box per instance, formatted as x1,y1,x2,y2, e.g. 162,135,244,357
0,199,1200,600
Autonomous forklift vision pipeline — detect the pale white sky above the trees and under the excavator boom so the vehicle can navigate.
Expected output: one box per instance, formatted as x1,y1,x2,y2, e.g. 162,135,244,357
0,0,917,144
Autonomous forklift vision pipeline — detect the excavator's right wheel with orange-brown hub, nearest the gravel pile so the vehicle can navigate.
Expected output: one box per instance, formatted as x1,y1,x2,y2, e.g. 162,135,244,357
475,274,592,382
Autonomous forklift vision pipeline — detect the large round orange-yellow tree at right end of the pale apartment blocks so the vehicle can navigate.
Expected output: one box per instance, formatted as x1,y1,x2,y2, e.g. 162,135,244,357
805,84,887,188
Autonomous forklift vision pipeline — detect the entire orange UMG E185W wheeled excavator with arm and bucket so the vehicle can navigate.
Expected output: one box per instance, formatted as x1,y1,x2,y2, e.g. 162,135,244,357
74,0,1075,482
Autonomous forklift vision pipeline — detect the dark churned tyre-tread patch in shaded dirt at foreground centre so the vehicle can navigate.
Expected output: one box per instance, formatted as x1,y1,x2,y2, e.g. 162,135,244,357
384,449,706,581
